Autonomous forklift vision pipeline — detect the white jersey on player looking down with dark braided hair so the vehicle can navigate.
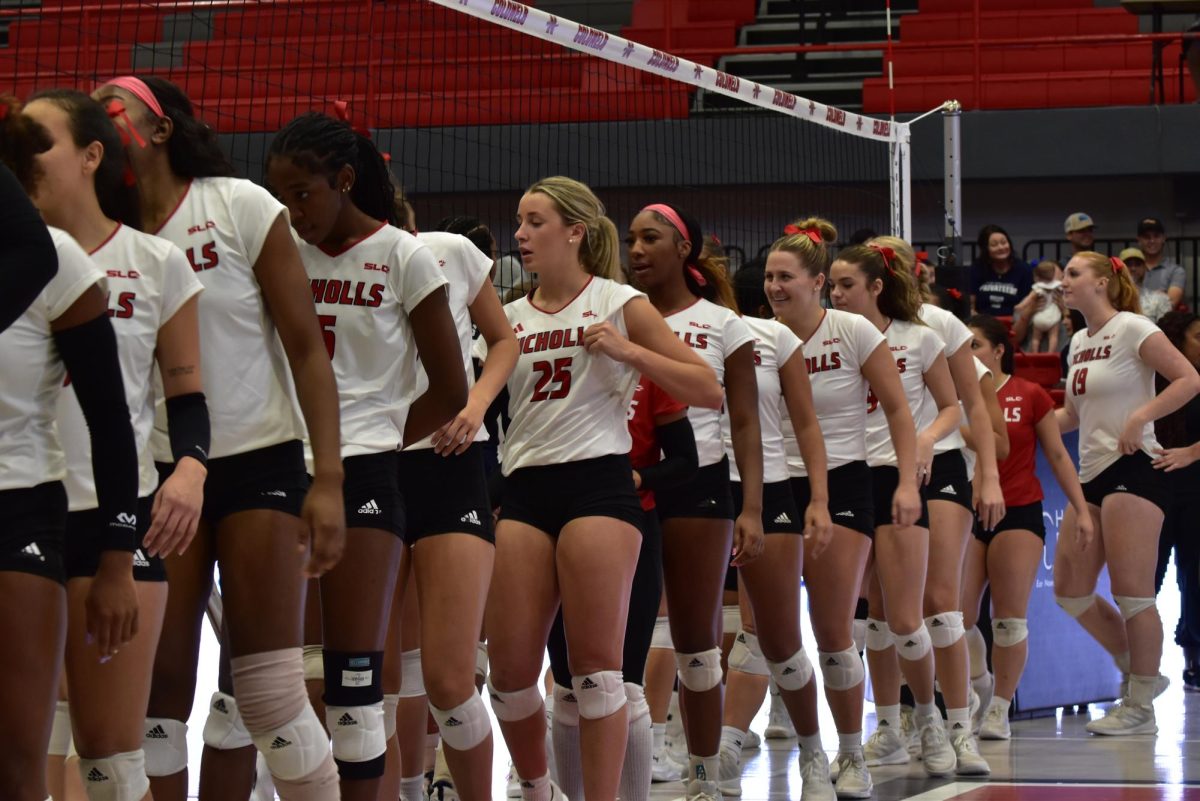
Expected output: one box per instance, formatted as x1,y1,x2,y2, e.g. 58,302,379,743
299,223,446,458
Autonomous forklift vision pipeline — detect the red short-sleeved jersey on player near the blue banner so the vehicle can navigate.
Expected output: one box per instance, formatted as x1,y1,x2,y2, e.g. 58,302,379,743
996,375,1054,506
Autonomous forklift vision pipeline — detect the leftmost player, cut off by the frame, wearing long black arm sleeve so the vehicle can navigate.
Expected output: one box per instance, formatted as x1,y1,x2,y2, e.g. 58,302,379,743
0,97,138,801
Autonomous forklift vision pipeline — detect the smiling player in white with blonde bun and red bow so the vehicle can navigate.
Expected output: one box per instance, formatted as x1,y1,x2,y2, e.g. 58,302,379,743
764,218,920,797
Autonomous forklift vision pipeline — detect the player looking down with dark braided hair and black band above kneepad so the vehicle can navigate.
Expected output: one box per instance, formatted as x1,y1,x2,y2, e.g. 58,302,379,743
266,112,474,801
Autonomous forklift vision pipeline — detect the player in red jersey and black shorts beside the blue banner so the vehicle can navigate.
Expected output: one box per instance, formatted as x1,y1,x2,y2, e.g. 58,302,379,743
962,314,1093,740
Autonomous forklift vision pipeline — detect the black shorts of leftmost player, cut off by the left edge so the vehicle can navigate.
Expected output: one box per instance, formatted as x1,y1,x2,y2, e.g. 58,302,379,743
0,481,67,582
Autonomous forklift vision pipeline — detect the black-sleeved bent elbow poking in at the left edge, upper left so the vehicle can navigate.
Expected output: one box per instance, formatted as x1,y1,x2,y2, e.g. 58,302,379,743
0,164,59,331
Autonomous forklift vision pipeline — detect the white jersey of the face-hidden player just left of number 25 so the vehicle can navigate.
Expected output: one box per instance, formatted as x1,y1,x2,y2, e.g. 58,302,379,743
404,231,492,451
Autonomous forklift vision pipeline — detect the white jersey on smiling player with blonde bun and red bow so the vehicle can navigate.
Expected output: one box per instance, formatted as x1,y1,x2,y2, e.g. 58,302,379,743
782,308,886,477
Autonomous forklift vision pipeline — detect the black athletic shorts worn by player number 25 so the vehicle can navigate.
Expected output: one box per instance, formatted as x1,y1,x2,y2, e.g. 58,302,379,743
500,453,648,537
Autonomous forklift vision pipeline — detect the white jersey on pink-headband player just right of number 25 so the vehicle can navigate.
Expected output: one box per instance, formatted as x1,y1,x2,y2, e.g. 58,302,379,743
665,297,754,468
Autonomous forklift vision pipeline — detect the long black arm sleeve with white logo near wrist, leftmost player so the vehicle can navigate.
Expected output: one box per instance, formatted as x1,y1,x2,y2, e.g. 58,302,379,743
54,314,139,552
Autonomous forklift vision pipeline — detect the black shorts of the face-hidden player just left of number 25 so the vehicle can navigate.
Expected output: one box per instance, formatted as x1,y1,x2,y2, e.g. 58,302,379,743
398,442,496,546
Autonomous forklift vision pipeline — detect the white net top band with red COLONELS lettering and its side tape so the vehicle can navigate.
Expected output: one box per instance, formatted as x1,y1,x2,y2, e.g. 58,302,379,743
428,0,912,241
